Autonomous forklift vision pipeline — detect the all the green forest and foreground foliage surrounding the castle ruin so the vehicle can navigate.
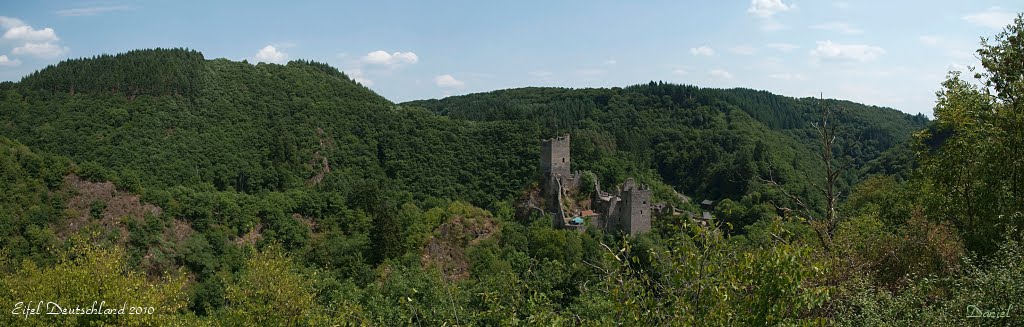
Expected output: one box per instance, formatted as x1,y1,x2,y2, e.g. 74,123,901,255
0,16,1024,326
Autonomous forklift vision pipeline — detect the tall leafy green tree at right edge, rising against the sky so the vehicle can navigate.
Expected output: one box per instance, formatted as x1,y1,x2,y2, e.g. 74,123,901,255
916,15,1024,255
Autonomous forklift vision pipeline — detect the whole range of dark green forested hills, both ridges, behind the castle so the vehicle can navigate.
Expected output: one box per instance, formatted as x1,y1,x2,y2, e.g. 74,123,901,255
0,49,926,233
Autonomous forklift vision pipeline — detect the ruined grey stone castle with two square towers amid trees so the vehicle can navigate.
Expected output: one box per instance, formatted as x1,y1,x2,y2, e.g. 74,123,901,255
541,135,651,235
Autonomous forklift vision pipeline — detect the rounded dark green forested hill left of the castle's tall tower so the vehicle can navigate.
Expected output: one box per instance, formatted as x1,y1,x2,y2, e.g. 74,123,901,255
0,49,539,205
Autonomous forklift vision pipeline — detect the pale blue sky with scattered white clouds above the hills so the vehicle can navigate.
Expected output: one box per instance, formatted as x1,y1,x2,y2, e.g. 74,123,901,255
0,0,1024,115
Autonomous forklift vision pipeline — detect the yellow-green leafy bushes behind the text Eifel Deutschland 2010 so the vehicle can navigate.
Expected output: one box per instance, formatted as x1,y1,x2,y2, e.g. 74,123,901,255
0,240,187,326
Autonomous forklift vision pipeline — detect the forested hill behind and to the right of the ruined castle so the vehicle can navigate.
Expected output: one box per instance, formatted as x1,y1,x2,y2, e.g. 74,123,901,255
402,82,928,227
